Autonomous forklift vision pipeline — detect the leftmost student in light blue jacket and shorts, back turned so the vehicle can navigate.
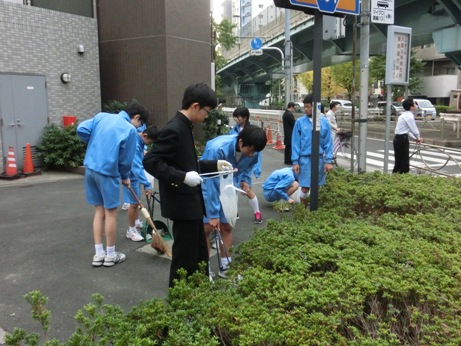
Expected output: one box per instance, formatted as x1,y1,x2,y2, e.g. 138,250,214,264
77,100,149,267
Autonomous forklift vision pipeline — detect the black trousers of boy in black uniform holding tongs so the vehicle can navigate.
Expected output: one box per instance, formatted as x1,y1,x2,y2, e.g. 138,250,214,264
169,219,209,287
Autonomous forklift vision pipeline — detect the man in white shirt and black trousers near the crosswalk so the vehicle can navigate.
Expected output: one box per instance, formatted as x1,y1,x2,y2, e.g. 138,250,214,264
392,98,423,173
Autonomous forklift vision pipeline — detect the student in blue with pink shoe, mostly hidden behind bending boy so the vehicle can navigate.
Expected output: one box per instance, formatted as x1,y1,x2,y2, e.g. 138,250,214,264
229,107,263,224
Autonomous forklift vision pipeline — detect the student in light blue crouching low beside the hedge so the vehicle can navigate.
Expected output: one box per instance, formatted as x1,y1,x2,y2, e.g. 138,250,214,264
262,167,299,204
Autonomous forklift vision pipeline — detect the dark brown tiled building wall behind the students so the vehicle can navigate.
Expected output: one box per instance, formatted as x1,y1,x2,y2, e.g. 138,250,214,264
97,0,211,126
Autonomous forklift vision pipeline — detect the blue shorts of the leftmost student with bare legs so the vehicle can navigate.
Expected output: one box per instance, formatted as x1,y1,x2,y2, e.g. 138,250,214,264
85,167,120,209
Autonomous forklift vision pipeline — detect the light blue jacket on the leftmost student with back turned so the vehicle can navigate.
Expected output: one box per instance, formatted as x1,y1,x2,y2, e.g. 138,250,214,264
77,111,139,180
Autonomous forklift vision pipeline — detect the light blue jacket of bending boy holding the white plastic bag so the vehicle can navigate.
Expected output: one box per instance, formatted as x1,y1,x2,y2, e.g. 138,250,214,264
200,135,258,219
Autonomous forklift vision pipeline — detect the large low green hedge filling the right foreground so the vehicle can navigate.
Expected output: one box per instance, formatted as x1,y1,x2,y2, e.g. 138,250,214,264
9,169,461,345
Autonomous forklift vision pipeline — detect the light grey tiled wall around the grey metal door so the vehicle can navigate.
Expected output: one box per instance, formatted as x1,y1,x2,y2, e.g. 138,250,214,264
0,0,101,172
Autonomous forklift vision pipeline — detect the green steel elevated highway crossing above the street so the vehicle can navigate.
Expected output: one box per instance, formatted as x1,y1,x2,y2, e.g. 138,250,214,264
217,0,461,103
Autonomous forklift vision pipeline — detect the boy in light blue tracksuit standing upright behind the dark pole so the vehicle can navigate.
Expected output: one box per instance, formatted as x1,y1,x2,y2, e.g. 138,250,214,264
291,94,333,207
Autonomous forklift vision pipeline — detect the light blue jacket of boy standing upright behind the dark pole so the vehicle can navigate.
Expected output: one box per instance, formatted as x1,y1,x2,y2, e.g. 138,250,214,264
291,116,333,165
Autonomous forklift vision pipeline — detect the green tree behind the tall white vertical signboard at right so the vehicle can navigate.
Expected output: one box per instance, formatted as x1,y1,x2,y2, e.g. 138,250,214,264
369,52,425,100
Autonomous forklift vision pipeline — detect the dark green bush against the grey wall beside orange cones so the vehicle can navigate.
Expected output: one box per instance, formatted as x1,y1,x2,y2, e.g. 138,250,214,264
37,124,86,169
